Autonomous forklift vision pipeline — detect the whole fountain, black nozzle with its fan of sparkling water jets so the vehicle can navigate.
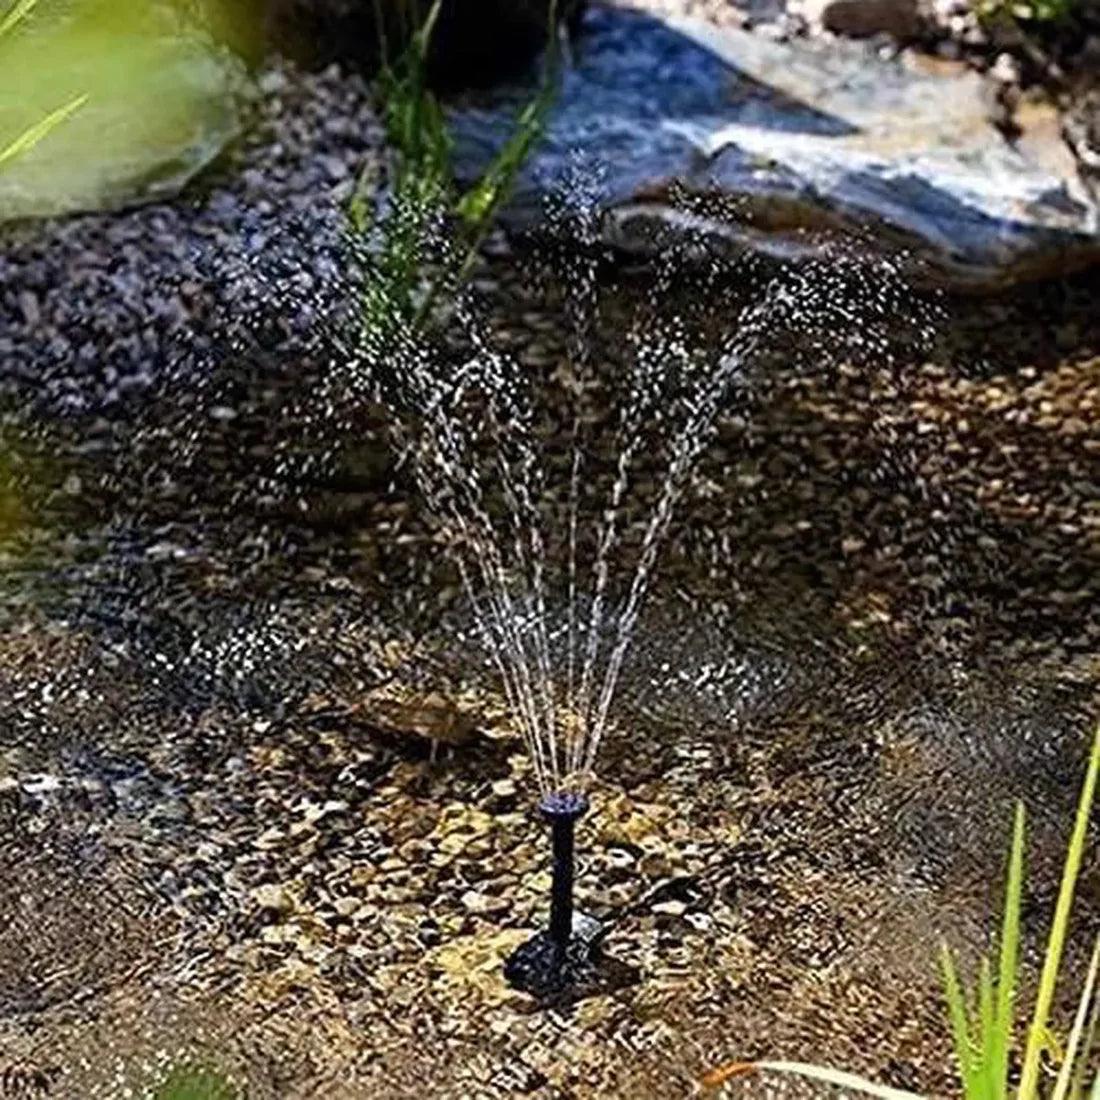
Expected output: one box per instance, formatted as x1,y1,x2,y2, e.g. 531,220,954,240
303,169,934,997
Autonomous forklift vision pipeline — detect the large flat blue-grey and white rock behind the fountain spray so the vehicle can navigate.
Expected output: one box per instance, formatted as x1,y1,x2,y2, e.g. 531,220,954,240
453,9,1100,289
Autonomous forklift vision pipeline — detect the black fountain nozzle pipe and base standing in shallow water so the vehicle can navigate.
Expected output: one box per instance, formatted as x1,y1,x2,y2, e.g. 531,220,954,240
504,792,605,997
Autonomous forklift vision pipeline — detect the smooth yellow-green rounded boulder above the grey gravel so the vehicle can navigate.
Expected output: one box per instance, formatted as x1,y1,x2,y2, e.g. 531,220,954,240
0,0,246,221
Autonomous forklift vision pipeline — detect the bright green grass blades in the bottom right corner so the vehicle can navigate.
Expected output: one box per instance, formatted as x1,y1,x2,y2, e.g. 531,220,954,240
703,727,1100,1100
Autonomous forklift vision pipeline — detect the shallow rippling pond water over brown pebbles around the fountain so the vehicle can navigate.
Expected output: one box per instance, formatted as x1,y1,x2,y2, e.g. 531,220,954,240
0,116,1100,1097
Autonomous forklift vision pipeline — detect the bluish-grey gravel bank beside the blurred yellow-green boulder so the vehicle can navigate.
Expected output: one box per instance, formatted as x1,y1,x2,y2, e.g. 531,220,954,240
0,62,382,416
